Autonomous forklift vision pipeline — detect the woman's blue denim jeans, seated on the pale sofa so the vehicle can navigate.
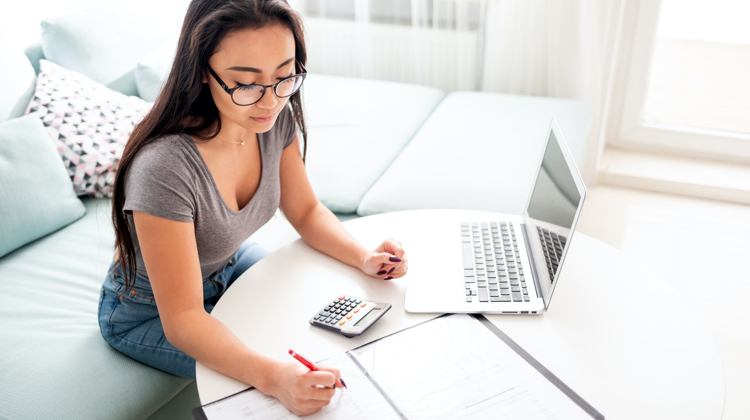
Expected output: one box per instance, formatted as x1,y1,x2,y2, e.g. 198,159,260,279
99,241,268,379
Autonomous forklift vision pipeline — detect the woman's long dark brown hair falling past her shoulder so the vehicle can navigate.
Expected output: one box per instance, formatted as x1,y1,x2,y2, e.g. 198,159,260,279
112,0,307,293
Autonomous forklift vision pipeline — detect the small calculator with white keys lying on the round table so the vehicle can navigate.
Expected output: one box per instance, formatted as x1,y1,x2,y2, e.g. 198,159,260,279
310,295,391,338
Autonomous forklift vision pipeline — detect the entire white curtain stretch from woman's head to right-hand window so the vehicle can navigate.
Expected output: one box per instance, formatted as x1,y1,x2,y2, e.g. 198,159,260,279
291,0,626,177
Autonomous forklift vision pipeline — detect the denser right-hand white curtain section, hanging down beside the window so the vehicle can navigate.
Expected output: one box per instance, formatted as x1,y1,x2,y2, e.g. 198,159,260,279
480,0,624,179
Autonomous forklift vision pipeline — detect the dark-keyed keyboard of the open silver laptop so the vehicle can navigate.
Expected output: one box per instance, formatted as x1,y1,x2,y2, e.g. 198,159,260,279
461,222,529,302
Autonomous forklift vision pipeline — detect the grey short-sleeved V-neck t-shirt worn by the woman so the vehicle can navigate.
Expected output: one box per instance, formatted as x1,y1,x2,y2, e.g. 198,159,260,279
123,107,297,279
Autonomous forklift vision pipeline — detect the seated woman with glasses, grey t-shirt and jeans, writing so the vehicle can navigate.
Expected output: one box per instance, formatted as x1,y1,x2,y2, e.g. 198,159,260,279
99,0,407,415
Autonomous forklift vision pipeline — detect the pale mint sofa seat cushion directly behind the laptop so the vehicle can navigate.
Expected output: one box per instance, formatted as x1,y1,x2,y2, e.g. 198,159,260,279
357,92,593,216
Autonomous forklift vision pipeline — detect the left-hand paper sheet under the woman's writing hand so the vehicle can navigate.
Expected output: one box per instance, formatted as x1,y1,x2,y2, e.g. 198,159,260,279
197,354,401,420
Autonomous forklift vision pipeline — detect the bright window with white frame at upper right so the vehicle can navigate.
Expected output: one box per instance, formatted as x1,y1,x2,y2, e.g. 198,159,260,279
610,0,750,161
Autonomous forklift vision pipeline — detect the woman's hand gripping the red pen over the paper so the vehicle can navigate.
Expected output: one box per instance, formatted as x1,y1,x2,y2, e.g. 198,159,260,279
261,362,344,416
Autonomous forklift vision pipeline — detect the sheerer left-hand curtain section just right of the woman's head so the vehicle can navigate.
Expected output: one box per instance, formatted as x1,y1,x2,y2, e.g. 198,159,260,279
291,0,486,92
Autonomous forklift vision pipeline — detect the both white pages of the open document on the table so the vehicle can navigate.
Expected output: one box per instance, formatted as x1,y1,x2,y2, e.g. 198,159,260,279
194,314,603,420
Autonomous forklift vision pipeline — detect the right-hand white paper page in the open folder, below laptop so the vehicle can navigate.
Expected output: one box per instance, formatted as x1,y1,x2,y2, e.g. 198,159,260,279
352,315,591,420
